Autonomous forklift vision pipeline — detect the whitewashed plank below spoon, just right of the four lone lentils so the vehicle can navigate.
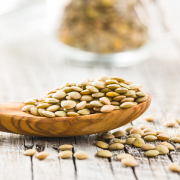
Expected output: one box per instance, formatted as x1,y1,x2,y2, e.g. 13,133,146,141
74,135,114,180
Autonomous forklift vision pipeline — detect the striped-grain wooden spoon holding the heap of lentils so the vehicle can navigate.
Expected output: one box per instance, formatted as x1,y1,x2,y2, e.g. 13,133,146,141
0,95,151,137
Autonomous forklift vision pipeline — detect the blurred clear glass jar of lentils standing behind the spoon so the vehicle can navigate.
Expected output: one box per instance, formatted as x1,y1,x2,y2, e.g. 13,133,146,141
46,0,151,67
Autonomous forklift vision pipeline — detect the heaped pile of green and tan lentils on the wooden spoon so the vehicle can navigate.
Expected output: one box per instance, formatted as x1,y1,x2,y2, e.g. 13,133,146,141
22,76,148,118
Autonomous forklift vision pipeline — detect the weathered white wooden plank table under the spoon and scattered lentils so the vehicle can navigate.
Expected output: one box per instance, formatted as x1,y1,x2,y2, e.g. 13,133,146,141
0,1,180,180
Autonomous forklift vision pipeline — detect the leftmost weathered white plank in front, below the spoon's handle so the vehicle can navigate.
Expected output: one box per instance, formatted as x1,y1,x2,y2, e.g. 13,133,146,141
0,133,32,180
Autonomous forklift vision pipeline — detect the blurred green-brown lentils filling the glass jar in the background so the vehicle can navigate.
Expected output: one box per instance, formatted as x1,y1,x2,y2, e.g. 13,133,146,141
58,0,148,54
